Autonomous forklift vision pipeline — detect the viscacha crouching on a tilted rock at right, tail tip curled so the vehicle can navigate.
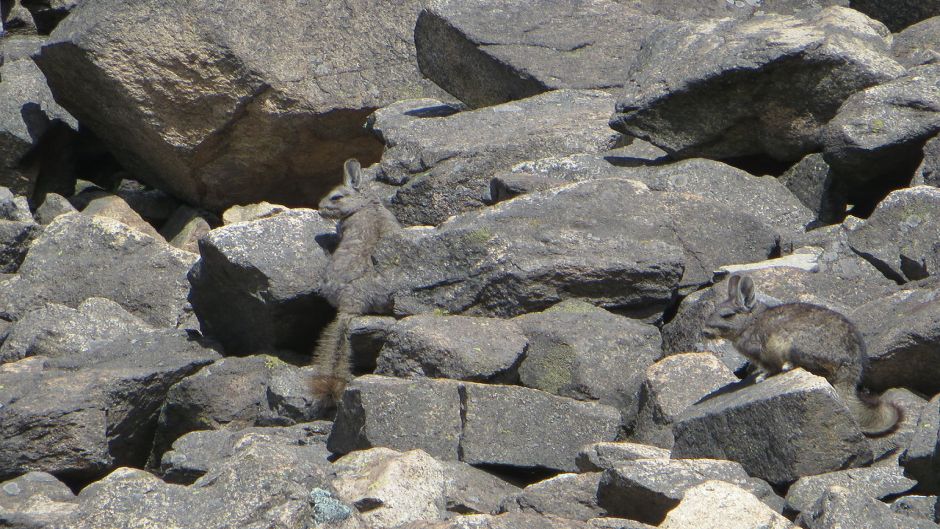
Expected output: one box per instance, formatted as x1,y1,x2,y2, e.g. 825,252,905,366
705,275,901,436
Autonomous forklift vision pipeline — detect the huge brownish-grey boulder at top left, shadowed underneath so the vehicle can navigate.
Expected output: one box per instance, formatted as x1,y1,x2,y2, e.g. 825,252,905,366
37,0,440,210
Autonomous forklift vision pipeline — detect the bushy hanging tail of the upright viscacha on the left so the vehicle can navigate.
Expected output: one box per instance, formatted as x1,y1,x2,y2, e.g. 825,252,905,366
310,312,356,406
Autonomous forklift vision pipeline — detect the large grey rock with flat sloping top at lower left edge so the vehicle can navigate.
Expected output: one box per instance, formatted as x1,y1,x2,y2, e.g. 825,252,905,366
0,330,219,481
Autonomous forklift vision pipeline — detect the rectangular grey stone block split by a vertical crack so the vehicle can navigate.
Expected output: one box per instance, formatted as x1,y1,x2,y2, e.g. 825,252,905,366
328,375,620,471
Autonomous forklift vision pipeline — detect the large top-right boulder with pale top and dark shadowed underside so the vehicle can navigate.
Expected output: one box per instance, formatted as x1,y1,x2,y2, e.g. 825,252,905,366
611,7,904,161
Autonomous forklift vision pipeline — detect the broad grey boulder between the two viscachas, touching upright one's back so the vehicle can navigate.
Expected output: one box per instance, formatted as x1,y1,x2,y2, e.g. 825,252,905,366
375,179,778,321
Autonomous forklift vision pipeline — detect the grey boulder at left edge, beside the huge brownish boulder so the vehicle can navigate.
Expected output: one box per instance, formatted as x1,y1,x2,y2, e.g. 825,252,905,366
0,38,78,194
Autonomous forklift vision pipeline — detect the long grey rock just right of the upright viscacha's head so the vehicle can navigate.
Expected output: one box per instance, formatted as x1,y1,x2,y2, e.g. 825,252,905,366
370,90,620,225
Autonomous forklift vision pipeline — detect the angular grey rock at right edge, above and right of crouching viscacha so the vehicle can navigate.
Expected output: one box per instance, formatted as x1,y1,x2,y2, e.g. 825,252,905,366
848,187,940,283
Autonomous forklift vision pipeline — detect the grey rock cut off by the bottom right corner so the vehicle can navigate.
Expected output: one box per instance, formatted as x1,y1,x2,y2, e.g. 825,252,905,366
796,486,938,529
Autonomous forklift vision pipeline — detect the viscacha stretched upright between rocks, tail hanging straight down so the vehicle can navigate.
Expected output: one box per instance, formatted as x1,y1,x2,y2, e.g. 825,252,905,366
313,159,401,399
